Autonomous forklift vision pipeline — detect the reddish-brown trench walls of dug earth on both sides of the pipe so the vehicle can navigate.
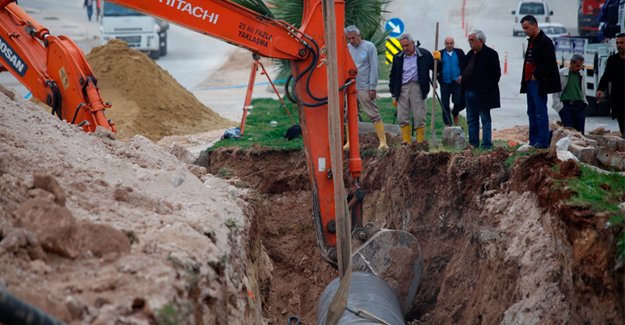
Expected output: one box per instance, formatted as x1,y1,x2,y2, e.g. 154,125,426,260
205,133,625,324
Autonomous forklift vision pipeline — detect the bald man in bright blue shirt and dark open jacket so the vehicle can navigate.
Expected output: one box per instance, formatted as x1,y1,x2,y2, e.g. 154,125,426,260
437,37,465,126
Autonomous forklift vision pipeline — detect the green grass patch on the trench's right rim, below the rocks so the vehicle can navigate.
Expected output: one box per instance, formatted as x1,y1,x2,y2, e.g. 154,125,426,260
567,166,625,261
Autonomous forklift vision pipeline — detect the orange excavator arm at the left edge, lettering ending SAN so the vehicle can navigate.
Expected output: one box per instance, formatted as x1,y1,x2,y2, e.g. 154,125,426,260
0,0,115,132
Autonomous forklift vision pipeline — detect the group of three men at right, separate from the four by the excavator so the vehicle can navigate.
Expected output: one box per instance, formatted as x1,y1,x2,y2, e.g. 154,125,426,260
521,16,625,141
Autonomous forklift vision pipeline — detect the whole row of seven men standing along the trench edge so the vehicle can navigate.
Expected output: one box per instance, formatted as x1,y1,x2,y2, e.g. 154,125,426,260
344,15,625,150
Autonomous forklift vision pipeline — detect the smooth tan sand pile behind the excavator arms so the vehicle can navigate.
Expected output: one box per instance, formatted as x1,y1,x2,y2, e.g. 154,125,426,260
87,40,232,141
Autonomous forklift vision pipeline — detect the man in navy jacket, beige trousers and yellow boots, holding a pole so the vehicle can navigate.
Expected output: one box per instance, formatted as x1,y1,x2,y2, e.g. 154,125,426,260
389,34,440,144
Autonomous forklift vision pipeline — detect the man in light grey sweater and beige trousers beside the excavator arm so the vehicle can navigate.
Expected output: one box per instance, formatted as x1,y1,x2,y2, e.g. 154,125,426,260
343,25,388,150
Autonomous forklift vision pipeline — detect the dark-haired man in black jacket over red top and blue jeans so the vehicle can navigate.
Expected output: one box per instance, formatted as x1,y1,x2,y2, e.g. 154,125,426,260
521,15,562,148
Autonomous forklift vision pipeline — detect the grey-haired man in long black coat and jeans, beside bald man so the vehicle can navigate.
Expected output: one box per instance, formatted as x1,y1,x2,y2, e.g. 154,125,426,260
462,30,501,149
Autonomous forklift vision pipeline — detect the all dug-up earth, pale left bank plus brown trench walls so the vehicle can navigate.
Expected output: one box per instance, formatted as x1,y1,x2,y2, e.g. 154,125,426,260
0,91,625,324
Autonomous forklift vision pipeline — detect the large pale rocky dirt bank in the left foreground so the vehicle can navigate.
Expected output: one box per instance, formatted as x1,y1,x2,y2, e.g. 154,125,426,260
0,94,261,324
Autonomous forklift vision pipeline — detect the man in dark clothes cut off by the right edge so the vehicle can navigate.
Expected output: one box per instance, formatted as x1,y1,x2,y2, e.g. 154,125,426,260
597,33,625,138
